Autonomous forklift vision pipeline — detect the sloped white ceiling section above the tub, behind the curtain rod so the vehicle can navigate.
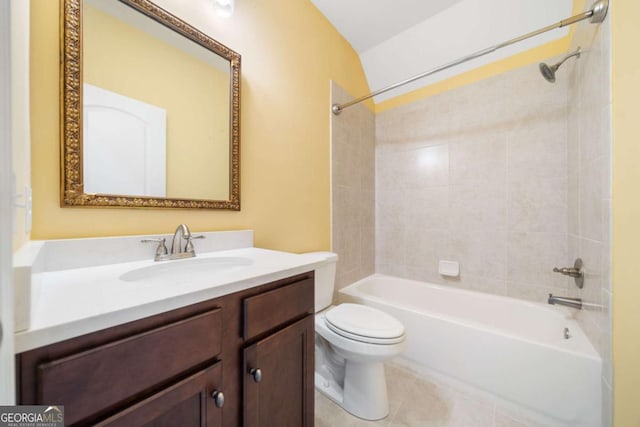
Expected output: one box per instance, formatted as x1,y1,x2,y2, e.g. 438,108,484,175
360,0,573,102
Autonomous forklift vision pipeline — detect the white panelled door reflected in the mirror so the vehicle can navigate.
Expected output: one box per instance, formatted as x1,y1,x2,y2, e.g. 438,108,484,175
83,83,167,197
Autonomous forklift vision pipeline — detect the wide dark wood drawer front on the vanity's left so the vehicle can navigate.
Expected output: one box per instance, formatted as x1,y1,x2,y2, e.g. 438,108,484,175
37,309,222,424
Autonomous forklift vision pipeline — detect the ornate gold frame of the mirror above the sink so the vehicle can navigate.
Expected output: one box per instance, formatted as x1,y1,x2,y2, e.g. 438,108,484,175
61,0,240,210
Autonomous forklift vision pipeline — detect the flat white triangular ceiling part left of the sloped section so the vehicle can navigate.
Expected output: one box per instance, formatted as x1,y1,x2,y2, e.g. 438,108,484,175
311,0,461,53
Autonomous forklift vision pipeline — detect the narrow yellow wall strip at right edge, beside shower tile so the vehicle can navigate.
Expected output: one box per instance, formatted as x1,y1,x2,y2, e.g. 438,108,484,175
611,1,640,427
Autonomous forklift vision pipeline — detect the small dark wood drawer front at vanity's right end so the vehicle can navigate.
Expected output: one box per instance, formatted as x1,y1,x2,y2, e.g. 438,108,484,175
243,277,314,340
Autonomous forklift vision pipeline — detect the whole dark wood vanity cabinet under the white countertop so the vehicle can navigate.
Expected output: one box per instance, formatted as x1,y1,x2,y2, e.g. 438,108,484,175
16,272,314,427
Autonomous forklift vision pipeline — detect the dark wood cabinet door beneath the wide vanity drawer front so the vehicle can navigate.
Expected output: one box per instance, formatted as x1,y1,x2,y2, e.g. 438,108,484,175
97,362,223,427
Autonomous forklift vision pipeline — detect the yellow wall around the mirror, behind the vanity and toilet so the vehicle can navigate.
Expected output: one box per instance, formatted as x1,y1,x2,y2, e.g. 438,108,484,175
31,0,369,252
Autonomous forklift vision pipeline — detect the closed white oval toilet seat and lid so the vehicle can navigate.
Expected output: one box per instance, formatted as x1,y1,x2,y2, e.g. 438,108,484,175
324,303,405,344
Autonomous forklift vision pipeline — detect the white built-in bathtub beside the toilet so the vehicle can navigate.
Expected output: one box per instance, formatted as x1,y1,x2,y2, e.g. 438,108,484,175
339,274,602,426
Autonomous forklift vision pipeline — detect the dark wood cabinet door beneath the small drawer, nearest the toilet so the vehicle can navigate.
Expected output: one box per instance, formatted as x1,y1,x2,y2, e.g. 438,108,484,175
243,315,314,427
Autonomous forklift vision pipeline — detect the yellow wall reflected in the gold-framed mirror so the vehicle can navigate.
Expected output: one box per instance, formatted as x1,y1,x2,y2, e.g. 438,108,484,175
82,3,229,200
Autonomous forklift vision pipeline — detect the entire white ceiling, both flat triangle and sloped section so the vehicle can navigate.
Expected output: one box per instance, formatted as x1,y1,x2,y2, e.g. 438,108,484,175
311,0,573,102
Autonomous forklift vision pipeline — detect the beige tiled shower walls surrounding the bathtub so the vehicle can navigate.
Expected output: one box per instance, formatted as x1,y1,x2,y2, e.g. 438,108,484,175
332,20,612,427
